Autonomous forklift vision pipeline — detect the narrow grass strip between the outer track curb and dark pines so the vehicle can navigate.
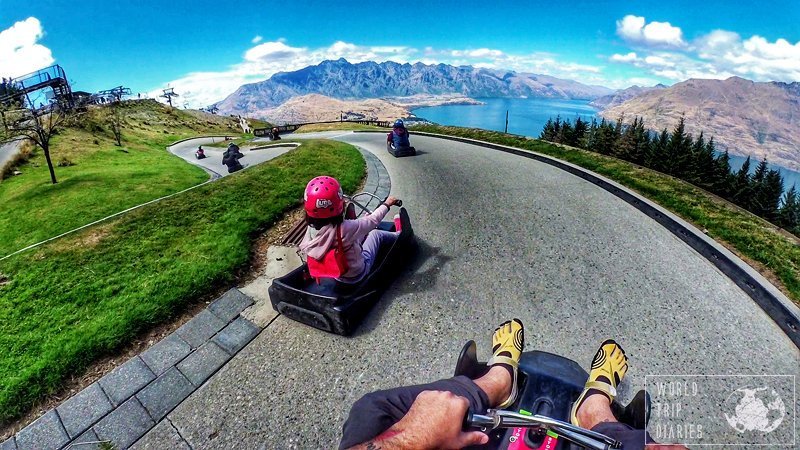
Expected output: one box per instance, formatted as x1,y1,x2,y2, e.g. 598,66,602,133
413,126,800,304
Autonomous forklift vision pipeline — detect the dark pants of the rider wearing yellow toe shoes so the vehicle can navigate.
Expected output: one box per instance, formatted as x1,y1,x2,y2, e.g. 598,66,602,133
339,376,653,450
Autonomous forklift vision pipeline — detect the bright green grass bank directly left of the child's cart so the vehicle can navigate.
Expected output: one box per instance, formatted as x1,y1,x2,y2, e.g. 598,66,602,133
0,140,365,422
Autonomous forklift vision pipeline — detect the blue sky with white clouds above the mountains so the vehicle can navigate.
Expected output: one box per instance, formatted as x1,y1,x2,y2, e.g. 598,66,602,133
0,0,800,106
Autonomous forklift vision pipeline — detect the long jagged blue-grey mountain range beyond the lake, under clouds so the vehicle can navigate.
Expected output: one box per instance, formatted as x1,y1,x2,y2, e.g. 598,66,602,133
217,59,613,115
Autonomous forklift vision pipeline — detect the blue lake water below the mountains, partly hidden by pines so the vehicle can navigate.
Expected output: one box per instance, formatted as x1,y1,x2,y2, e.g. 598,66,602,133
411,98,800,189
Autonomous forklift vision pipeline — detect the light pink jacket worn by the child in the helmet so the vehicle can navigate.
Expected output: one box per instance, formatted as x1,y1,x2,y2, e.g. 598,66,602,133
300,205,389,278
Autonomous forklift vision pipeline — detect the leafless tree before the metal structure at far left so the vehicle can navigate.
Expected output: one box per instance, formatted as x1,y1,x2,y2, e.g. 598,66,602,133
0,96,67,184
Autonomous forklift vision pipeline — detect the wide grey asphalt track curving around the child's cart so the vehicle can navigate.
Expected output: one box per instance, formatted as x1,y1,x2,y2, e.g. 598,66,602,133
139,133,800,449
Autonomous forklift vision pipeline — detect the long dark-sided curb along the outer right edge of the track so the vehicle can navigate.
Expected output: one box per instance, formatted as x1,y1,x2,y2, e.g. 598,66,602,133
355,130,800,348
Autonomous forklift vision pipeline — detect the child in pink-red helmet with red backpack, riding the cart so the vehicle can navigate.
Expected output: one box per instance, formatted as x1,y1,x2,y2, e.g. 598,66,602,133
300,176,398,283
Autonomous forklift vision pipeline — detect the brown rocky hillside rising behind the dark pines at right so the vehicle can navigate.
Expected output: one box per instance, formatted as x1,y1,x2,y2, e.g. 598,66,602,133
601,77,800,170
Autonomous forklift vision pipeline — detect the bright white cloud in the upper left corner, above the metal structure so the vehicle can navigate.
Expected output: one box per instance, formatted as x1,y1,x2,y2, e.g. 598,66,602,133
0,17,55,78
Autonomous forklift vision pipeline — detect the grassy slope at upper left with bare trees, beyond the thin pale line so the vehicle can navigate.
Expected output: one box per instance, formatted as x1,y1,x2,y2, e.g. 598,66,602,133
0,101,250,256
